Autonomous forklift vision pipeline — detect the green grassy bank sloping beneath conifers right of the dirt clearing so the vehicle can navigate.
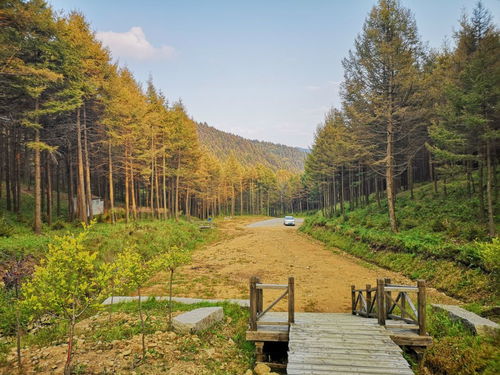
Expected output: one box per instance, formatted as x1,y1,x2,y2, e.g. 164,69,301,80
301,175,500,304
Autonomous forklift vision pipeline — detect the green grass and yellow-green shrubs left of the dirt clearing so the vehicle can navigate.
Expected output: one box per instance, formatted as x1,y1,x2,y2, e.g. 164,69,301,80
0,210,222,374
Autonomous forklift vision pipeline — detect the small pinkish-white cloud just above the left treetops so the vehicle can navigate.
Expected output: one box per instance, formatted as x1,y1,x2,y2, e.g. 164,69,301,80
96,26,176,60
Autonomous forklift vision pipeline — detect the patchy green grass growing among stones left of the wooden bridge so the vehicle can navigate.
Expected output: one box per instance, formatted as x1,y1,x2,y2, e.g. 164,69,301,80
0,298,255,374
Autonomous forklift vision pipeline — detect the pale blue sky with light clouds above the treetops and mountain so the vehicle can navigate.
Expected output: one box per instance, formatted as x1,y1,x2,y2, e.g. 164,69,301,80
48,0,500,148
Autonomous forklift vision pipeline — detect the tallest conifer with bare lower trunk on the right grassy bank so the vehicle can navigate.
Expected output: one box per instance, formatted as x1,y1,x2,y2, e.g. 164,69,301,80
343,0,423,232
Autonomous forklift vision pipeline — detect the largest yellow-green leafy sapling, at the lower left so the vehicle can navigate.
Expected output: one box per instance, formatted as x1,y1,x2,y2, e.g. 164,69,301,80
25,225,109,375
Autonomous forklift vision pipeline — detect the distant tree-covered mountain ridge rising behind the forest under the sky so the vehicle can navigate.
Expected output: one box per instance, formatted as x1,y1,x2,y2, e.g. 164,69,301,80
197,123,308,172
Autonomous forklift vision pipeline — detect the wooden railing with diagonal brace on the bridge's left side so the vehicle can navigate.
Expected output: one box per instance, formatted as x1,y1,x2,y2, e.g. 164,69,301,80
250,276,295,331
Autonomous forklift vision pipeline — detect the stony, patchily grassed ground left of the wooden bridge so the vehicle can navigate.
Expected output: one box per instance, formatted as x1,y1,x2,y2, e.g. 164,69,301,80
0,299,255,375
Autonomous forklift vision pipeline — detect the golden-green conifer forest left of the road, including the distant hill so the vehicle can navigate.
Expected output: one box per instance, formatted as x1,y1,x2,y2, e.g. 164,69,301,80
0,1,307,233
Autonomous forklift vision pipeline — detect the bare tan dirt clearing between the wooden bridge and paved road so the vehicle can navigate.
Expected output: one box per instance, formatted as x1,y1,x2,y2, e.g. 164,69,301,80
144,218,457,312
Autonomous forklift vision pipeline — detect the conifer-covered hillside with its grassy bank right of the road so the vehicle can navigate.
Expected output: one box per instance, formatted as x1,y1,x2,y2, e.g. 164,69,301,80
304,1,500,302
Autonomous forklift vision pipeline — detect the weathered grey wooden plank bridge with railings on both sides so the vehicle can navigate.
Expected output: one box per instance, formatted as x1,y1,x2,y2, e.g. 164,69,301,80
247,277,432,375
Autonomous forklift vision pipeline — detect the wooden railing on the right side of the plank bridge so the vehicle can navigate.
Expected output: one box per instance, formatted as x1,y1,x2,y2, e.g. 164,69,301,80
351,279,427,336
